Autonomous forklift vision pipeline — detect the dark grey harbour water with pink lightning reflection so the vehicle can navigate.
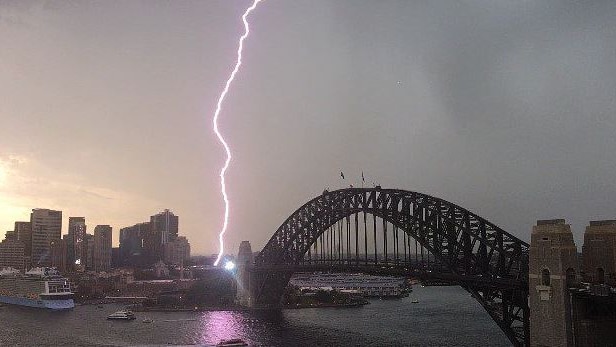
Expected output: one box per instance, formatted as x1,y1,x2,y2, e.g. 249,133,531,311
0,286,510,346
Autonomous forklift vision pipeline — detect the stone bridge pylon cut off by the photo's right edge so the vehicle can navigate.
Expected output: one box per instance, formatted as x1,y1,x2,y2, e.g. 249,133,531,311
582,220,616,286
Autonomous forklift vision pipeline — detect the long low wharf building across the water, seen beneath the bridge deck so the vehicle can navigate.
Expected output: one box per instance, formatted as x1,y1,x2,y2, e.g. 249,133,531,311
289,273,408,297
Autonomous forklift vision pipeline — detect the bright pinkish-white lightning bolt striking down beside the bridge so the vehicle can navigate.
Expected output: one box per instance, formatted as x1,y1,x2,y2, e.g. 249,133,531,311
213,0,262,266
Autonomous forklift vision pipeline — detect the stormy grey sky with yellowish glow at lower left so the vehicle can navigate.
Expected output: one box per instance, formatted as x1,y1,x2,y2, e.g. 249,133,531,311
0,0,616,254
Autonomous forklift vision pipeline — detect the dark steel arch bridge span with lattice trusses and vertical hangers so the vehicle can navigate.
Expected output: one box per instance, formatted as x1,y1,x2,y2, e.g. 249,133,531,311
253,186,529,345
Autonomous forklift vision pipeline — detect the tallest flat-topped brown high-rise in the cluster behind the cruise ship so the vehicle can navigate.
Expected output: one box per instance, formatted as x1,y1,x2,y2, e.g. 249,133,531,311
30,208,62,266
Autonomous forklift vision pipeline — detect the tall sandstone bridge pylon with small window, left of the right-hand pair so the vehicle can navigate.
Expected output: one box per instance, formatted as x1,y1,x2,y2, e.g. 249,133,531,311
528,219,579,346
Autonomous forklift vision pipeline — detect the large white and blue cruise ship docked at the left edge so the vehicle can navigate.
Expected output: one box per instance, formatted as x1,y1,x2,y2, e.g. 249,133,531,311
0,267,75,310
